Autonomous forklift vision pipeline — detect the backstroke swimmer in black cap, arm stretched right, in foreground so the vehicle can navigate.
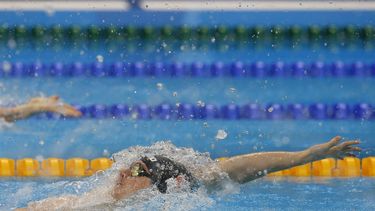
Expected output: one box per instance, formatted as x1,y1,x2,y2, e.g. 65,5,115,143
16,136,361,210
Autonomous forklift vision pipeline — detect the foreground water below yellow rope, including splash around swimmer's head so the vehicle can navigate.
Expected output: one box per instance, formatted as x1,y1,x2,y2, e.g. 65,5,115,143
0,142,375,210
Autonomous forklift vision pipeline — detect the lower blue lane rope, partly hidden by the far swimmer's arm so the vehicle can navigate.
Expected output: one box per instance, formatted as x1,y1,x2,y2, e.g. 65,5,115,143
37,103,375,120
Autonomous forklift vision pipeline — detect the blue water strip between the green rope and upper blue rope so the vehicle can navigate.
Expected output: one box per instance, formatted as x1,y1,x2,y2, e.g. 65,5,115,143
0,41,375,63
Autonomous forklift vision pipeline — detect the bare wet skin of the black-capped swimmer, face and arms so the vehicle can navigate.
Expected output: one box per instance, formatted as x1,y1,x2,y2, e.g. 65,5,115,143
16,136,361,210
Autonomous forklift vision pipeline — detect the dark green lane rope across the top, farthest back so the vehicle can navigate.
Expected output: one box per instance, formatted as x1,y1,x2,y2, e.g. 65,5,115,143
0,25,375,43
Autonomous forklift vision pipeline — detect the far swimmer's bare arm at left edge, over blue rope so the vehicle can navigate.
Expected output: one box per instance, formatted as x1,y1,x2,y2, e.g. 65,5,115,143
0,96,81,122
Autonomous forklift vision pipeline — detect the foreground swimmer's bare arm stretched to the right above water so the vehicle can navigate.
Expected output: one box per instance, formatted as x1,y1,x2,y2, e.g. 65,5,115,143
219,136,361,183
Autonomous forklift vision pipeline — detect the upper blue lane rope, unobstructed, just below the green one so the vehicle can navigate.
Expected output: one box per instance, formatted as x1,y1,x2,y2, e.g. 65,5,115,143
0,61,375,78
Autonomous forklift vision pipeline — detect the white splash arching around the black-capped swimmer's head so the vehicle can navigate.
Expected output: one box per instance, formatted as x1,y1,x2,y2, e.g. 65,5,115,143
19,142,238,210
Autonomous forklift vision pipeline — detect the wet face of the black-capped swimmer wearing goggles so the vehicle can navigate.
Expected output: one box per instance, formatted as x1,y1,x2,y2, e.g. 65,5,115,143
112,165,152,200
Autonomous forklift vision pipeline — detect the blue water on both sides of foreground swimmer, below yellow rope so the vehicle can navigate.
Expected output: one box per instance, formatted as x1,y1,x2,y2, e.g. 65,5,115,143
0,178,375,210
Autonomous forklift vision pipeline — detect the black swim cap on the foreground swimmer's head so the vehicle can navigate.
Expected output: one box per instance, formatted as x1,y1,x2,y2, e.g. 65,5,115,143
141,155,198,193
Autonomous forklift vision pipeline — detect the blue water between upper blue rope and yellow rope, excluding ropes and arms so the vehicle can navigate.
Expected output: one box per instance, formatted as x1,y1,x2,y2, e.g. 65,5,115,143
0,77,375,158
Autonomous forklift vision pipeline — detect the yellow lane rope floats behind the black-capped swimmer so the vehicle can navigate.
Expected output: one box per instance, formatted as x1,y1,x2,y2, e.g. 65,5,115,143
0,157,375,177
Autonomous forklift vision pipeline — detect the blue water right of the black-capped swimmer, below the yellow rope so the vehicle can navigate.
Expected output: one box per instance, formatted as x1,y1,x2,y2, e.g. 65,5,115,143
212,179,375,210
